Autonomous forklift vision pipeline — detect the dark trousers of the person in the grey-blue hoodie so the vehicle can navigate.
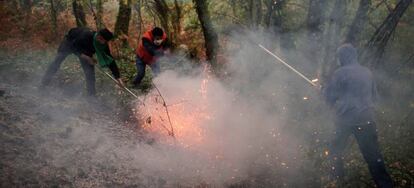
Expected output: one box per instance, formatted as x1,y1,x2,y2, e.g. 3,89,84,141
331,122,392,188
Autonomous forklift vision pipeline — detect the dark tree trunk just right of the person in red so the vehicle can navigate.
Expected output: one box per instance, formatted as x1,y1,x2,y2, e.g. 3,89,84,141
193,0,219,70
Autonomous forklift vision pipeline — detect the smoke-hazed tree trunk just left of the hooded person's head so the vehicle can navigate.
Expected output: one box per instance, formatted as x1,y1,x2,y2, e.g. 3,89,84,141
317,0,347,82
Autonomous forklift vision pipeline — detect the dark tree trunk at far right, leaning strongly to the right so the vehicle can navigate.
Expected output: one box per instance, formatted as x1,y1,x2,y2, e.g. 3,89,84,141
363,0,413,67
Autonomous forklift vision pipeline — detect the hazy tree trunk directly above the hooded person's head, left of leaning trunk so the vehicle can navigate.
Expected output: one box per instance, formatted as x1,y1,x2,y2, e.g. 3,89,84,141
345,0,371,46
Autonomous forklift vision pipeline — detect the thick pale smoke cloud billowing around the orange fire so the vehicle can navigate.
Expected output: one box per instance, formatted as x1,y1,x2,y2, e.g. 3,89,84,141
104,30,330,186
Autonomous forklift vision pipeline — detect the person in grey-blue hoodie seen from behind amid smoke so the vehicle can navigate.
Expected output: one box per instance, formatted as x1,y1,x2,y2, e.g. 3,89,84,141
324,44,392,187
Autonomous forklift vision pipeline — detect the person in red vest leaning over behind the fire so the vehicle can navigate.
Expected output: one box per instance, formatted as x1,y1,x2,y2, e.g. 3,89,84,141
132,27,167,87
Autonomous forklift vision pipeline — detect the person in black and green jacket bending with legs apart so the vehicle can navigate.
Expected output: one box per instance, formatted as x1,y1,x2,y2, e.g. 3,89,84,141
42,27,124,96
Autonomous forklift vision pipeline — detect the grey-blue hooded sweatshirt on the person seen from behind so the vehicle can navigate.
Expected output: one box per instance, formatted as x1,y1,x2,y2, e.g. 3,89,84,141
324,44,377,126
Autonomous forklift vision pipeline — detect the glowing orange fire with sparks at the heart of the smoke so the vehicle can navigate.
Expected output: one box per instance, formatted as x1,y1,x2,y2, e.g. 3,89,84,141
138,66,213,148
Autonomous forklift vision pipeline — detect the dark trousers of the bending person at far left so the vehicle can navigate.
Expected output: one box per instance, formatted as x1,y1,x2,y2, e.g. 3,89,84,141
42,41,96,96
